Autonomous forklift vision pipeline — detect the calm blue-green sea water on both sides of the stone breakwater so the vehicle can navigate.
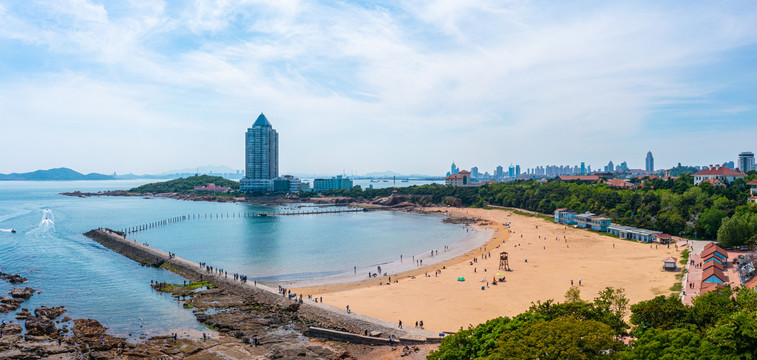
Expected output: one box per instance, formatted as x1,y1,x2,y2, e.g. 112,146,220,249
0,180,466,336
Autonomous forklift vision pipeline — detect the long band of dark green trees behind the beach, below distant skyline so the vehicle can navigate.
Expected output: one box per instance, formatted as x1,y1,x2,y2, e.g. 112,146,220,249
326,172,757,239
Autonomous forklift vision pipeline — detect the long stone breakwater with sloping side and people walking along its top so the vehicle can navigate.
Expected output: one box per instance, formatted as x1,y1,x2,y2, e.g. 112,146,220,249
84,228,441,344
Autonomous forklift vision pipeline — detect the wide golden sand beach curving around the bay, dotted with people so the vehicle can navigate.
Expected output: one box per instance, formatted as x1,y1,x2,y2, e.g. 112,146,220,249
292,207,683,332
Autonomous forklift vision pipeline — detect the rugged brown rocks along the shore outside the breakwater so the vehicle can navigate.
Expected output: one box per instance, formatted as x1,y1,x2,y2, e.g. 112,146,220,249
0,266,386,359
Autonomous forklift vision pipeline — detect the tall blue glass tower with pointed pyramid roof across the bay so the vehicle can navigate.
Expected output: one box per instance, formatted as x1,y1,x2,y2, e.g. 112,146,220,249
239,113,279,191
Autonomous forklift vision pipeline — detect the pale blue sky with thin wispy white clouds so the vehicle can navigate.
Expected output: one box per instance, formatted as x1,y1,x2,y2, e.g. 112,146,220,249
0,0,757,175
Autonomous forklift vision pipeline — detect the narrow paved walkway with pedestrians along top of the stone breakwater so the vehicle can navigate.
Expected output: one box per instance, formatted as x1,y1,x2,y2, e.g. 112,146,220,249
95,229,439,340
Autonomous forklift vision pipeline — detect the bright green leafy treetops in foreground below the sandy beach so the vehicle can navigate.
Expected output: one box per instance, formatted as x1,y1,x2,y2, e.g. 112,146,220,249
428,288,757,360
